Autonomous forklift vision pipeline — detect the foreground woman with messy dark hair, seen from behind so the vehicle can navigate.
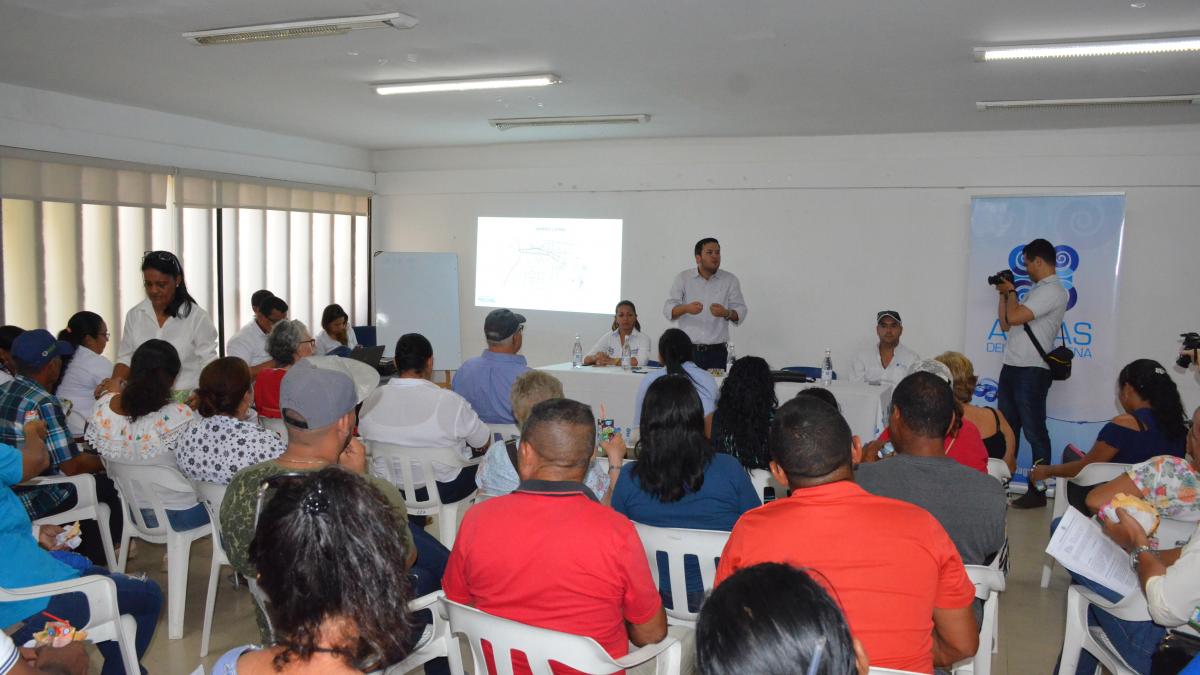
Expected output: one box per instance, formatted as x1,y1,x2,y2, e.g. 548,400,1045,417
212,466,413,675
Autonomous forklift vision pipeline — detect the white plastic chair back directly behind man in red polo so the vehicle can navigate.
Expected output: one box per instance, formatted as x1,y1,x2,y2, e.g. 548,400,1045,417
442,599,683,675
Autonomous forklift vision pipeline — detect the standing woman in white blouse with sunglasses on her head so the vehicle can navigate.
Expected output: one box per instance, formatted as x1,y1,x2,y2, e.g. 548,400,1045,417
113,251,217,393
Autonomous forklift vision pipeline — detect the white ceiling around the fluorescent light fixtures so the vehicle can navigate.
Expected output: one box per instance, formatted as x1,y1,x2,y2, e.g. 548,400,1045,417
0,0,1200,149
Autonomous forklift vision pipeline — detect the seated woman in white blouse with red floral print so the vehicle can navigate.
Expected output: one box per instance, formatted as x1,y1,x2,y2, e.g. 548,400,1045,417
84,339,209,532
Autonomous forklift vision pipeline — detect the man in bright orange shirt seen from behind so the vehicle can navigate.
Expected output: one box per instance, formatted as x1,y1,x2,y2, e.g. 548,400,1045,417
716,396,979,673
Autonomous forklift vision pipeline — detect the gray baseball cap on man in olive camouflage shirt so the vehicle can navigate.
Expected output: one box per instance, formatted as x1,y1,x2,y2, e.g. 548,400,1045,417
280,359,359,429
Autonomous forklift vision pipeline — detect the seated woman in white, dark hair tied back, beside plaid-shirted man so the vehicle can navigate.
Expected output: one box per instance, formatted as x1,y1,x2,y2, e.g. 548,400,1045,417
56,311,113,437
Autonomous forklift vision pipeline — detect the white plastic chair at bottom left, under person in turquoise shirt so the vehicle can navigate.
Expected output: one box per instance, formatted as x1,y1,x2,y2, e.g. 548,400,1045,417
0,575,142,675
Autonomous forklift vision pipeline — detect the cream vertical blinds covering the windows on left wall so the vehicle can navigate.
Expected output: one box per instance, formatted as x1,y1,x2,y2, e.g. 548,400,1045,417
0,148,371,358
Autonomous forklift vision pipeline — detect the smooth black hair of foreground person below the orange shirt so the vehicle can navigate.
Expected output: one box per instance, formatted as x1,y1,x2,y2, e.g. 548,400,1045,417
696,562,858,675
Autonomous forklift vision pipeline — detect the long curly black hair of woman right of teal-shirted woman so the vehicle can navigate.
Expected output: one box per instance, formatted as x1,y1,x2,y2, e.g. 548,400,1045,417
713,357,779,471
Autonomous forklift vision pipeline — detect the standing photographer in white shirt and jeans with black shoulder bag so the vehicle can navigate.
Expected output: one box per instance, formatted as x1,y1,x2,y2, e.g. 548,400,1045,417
988,239,1069,508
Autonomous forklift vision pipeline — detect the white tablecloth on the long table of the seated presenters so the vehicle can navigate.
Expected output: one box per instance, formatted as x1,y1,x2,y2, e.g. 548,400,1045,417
538,363,892,443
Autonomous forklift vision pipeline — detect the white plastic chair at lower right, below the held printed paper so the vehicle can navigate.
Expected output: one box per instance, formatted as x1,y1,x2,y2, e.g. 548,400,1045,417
1058,584,1150,675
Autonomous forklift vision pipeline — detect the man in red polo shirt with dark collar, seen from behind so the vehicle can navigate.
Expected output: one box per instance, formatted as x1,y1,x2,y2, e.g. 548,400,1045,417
442,399,667,673
